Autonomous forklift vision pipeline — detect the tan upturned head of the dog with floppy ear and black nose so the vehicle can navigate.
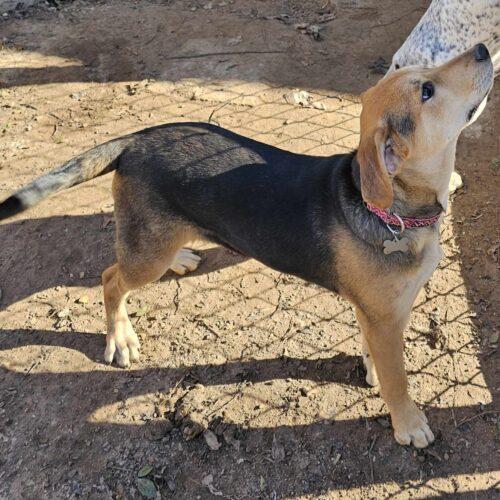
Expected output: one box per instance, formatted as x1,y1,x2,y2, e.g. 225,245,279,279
357,44,493,208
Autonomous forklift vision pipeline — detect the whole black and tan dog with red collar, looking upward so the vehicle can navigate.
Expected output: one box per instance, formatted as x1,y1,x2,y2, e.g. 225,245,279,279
0,44,493,447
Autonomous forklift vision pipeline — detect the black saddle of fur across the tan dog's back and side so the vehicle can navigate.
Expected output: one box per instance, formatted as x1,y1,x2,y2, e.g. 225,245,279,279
117,123,354,289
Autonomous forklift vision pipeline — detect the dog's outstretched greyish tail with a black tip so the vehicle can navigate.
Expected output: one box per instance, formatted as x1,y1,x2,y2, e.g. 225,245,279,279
0,137,129,220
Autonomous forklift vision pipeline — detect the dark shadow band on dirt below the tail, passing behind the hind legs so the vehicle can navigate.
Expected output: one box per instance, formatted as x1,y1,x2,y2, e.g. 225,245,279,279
0,213,247,310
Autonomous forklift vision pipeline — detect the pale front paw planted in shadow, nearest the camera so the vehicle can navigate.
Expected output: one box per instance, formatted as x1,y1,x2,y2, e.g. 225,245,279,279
391,400,434,448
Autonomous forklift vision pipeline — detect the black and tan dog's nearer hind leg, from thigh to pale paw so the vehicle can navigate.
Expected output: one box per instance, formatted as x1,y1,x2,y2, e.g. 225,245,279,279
102,175,198,366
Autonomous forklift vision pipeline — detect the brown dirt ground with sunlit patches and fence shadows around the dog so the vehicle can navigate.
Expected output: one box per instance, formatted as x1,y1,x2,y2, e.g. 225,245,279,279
0,0,500,500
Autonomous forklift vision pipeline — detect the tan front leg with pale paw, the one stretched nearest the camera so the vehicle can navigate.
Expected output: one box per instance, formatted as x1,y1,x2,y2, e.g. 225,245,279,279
356,308,434,448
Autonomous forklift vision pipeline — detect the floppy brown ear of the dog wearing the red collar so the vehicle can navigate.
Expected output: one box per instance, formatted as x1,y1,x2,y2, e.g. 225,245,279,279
357,125,409,209
